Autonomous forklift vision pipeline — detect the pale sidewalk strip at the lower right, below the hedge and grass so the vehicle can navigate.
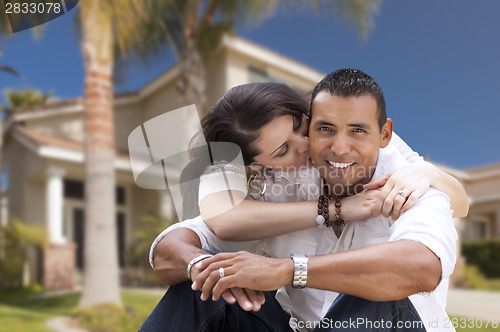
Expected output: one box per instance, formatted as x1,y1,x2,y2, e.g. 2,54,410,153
446,289,500,320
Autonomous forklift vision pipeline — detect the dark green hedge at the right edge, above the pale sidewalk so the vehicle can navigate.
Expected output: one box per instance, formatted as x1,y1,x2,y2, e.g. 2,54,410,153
462,239,500,278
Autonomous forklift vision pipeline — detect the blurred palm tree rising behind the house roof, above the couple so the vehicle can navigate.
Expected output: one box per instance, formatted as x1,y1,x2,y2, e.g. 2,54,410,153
136,0,382,110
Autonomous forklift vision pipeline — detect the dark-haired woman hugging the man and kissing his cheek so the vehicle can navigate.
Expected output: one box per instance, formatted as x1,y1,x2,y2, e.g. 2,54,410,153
150,83,468,258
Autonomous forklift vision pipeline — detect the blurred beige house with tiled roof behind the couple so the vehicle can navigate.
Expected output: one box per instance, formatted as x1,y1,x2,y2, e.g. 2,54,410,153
0,36,500,288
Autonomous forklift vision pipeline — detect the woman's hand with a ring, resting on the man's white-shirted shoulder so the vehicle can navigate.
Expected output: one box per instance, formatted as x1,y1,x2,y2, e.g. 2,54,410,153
365,161,436,220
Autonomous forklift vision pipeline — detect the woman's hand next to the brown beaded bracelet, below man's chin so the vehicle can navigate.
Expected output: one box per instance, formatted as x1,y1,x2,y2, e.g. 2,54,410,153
338,186,380,221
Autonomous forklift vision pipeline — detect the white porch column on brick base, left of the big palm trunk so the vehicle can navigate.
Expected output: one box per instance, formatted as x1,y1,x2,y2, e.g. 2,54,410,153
45,167,66,243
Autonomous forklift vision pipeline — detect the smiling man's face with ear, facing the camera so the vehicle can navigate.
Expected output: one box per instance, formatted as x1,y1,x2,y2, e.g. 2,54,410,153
309,91,392,197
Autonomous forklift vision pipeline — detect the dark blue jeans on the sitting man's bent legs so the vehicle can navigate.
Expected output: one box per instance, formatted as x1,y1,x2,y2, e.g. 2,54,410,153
139,282,425,332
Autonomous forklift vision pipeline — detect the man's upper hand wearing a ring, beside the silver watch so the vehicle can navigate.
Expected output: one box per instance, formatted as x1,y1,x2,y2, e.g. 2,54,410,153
193,251,293,301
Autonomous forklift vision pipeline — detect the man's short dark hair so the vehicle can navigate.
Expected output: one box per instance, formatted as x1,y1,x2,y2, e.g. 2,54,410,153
309,69,387,130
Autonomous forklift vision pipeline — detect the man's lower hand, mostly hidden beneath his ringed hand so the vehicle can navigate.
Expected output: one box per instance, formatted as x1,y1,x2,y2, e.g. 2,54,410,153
191,254,266,311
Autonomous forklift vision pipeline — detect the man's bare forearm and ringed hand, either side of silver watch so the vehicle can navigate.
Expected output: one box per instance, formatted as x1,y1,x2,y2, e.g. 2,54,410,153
194,240,441,301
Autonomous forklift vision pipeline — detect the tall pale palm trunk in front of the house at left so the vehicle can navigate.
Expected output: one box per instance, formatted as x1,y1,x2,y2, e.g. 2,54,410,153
80,1,121,307
